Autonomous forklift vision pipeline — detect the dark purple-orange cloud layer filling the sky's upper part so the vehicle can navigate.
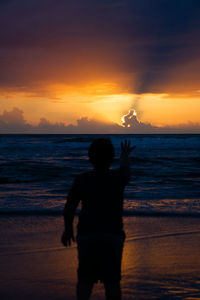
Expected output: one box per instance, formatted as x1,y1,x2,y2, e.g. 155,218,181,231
0,0,200,93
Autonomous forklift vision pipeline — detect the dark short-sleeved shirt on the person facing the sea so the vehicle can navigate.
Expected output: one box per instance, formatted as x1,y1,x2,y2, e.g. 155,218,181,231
67,168,130,235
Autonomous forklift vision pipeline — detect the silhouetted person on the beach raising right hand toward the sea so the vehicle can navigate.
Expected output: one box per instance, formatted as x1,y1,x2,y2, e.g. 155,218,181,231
62,138,134,300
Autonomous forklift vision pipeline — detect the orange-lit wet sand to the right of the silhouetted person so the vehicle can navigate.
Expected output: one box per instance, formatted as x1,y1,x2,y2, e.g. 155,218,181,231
122,218,200,299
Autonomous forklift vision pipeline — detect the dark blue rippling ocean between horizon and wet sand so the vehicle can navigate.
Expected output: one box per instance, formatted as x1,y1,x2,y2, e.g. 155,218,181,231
0,134,200,216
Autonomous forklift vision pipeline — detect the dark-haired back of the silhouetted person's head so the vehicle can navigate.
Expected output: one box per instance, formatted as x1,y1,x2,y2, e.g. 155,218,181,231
88,138,115,168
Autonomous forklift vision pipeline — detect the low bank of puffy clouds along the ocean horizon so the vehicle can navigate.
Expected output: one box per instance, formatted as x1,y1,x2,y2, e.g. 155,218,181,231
0,107,200,134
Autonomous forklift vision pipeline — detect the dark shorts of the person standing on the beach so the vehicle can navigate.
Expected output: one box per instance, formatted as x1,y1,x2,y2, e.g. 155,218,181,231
77,232,125,283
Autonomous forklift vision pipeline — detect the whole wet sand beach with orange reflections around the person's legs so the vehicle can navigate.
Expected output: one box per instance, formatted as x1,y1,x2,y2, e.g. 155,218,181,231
0,216,200,300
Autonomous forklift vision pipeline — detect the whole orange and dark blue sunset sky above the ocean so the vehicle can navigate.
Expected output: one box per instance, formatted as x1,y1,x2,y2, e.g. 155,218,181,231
0,0,200,133
